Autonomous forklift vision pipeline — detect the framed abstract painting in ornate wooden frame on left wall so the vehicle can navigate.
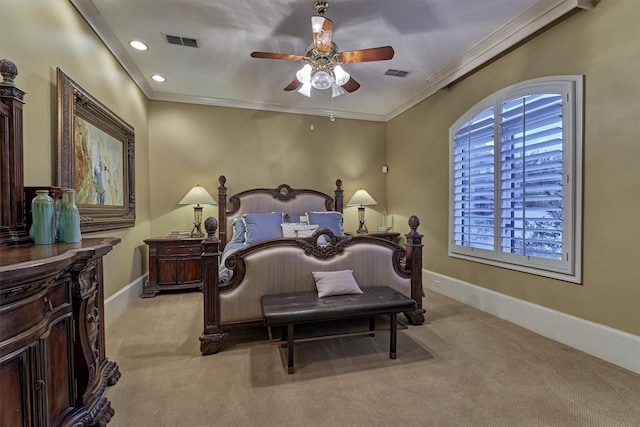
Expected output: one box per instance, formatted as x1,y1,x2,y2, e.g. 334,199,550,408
57,68,136,232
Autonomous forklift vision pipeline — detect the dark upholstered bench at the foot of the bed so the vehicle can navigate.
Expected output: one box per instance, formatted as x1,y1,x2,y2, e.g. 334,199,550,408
261,286,416,374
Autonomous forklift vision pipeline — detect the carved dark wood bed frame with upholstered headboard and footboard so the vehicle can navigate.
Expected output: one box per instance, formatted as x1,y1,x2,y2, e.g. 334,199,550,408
200,176,425,354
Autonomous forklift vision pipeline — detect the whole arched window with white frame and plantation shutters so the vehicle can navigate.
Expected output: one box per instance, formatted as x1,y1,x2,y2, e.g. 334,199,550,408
449,76,583,283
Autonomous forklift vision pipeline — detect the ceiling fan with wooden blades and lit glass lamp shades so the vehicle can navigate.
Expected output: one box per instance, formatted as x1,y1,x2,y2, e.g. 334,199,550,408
251,1,394,97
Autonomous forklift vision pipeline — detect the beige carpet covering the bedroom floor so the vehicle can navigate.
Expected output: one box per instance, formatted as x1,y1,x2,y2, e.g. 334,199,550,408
107,292,640,427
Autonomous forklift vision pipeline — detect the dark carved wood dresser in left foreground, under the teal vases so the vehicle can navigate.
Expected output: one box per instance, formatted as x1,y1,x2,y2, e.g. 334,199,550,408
0,238,120,426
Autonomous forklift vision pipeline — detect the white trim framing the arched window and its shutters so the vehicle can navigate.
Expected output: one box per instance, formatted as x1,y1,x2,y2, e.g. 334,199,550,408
448,75,584,283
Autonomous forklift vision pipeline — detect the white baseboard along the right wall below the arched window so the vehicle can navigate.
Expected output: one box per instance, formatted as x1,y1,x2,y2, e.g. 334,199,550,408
422,270,640,374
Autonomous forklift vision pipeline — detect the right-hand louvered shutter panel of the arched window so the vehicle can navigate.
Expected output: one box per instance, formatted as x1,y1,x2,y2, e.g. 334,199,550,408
499,94,563,260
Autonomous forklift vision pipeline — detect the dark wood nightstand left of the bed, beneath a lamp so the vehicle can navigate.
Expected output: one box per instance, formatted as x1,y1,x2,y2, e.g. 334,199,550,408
142,237,203,298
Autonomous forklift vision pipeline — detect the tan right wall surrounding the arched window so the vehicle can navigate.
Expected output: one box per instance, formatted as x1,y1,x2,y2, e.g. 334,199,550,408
387,0,640,335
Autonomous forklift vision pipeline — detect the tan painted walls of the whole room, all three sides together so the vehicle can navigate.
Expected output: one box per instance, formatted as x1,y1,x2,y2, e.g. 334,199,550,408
5,0,640,334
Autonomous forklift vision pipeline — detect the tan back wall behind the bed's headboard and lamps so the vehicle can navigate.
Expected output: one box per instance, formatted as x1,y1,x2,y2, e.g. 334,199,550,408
149,103,386,235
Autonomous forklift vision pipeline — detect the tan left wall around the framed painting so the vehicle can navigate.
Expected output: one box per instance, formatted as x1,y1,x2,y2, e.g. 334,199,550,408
0,0,150,297
